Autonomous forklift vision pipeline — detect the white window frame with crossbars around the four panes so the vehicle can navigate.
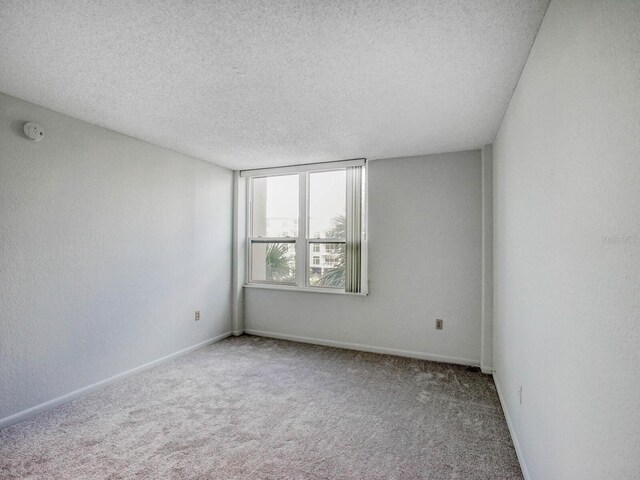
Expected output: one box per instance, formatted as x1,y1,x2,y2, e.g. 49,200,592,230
240,159,369,295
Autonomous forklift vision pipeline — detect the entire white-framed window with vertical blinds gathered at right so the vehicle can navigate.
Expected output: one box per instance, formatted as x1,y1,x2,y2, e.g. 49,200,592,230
241,160,366,293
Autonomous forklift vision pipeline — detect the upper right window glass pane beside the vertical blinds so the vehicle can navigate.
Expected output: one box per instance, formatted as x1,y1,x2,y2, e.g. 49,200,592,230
309,170,346,238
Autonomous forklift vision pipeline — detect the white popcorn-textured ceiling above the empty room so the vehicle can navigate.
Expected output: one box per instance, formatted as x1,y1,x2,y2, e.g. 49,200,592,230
0,0,548,169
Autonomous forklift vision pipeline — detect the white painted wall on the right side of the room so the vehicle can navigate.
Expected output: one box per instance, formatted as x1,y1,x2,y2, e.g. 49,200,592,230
494,0,640,480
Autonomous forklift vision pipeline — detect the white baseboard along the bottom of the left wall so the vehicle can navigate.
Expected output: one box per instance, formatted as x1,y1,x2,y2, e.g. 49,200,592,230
0,332,231,429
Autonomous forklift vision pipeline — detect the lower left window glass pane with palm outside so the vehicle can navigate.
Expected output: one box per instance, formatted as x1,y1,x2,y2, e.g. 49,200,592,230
251,243,296,283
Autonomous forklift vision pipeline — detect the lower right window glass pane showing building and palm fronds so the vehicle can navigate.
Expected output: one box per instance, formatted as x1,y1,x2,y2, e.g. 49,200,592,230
307,243,346,288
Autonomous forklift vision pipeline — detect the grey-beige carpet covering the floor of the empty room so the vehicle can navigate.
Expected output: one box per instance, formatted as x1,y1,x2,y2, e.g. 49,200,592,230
0,336,522,480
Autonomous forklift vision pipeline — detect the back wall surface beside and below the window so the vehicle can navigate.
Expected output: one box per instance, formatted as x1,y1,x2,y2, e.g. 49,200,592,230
244,151,482,365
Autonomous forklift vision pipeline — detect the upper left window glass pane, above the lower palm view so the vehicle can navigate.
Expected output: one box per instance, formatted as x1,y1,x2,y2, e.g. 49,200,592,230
252,175,299,237
